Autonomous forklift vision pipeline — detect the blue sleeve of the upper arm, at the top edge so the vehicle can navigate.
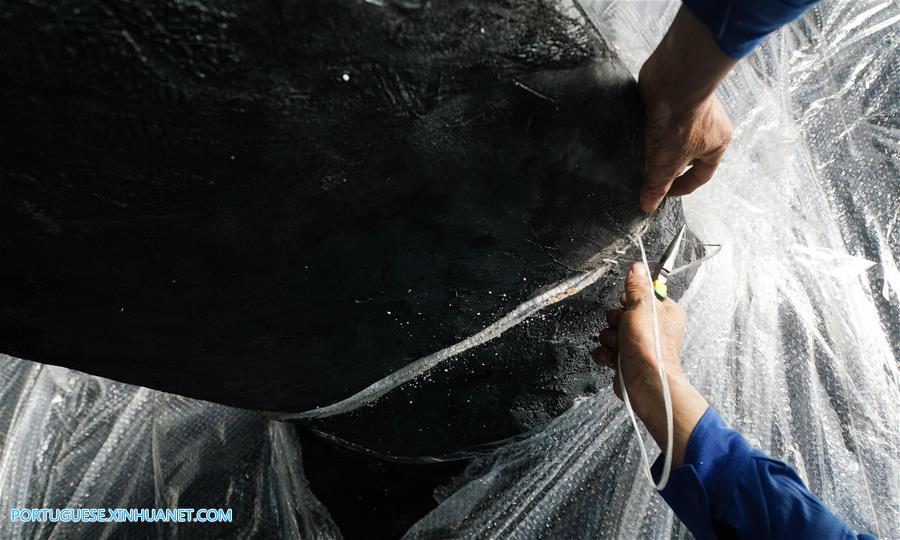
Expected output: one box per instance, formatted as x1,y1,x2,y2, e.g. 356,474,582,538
683,0,818,58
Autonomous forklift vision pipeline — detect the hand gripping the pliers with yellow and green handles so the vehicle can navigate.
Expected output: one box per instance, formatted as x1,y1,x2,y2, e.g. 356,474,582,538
592,263,685,417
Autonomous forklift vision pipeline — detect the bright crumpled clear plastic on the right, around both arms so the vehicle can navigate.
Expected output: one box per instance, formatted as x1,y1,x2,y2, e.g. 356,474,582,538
407,1,900,538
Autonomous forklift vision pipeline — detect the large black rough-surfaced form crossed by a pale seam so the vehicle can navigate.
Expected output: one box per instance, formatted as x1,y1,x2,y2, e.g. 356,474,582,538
0,0,668,456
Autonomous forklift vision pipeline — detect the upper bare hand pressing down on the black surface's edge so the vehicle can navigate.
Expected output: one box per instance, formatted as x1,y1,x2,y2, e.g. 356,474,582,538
638,7,737,212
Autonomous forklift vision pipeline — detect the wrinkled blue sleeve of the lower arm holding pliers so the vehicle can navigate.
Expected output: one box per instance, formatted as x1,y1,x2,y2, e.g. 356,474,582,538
653,407,874,540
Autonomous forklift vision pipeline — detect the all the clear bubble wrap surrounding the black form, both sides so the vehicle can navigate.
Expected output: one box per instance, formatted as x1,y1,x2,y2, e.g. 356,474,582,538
0,1,900,538
